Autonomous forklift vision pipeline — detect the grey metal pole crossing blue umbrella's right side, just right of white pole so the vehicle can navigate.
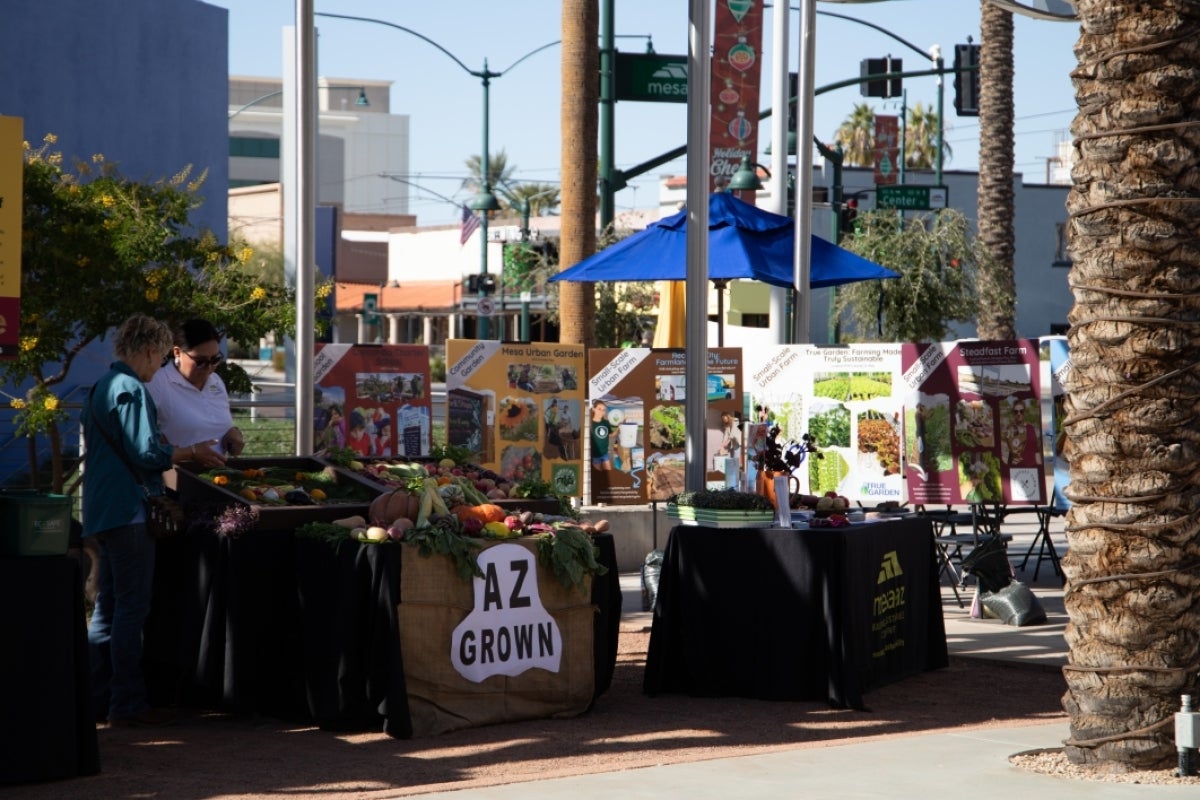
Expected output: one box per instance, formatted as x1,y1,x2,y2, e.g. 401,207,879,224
792,0,817,344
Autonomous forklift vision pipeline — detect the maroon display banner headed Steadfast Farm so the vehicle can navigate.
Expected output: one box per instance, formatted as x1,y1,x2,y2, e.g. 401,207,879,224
901,339,1045,505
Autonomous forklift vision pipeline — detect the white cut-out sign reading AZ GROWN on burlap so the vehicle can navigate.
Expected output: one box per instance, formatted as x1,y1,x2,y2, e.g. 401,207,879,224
450,545,563,682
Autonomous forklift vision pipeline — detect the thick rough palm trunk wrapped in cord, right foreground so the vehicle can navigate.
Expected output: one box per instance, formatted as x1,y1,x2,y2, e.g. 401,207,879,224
1062,0,1200,771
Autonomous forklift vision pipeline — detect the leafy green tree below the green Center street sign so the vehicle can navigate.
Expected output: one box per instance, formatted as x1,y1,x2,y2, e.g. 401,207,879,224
835,209,986,342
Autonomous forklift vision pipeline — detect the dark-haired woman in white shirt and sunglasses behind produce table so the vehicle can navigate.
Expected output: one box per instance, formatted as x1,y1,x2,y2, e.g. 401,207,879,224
148,319,245,468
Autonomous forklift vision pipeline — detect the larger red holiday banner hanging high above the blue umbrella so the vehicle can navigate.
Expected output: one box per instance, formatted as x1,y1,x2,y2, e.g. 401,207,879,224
708,0,762,196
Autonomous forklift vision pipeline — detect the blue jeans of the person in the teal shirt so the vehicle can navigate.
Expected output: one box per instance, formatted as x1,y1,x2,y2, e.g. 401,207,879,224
88,523,155,720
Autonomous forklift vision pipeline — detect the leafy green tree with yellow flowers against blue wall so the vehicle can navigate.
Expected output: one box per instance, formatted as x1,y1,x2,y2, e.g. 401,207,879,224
8,134,331,492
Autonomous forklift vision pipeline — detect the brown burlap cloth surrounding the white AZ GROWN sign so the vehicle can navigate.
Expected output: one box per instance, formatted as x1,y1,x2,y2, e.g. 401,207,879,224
397,540,596,736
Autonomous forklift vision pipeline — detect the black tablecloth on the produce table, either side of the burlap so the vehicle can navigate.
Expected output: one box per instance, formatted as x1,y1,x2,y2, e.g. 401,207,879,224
146,530,620,736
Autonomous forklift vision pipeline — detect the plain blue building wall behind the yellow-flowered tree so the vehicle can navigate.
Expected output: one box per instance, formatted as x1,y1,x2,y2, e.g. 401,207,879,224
0,0,229,483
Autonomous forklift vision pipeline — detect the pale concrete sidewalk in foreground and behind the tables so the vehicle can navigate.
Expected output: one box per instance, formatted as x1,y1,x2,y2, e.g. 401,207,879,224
410,519,1196,800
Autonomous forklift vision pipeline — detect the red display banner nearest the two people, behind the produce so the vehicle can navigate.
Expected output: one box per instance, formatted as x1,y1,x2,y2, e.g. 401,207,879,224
312,343,432,458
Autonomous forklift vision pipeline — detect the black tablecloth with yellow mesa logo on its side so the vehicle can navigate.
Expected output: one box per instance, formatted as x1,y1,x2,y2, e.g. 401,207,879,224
644,521,948,709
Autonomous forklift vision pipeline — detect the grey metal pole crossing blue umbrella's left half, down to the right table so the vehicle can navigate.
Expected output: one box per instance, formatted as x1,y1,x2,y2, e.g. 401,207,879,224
684,0,710,492
